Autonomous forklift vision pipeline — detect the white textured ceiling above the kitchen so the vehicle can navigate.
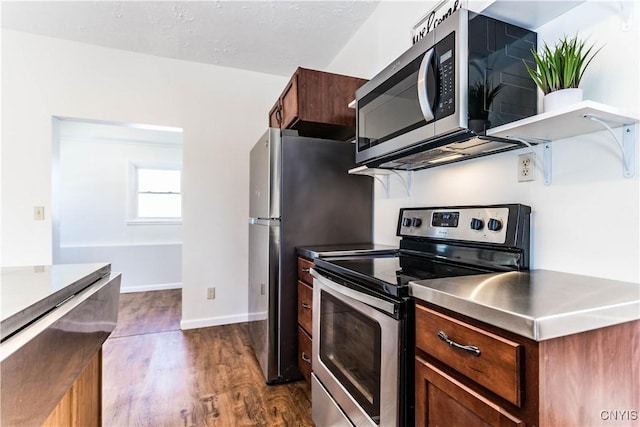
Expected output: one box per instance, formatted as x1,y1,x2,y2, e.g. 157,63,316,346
1,0,379,77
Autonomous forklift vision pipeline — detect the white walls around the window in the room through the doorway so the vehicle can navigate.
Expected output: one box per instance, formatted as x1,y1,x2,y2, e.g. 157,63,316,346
54,121,182,247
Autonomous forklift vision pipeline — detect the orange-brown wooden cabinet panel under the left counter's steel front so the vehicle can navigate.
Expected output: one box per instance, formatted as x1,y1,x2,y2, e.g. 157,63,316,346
42,350,102,427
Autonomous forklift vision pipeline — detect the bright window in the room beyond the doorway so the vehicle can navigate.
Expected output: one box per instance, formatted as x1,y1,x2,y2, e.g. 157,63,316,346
131,165,182,223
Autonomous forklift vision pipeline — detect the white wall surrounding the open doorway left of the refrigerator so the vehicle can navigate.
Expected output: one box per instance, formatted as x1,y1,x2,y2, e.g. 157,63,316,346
2,29,286,327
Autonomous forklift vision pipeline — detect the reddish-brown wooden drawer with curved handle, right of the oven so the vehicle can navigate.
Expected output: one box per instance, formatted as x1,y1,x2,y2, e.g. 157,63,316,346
416,305,524,406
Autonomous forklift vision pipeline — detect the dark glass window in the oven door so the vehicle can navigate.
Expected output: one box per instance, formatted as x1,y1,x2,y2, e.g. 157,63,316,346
320,292,381,422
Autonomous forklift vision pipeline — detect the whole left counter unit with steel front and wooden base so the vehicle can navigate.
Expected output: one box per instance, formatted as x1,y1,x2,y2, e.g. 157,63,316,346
0,264,121,427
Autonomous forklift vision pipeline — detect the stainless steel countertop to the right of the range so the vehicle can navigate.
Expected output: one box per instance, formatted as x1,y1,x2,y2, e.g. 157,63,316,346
409,270,640,341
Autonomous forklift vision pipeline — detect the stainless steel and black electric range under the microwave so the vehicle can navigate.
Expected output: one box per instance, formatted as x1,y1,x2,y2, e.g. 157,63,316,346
312,204,531,427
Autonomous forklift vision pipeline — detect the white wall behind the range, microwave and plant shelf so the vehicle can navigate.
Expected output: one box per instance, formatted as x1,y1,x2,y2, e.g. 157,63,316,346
329,1,640,282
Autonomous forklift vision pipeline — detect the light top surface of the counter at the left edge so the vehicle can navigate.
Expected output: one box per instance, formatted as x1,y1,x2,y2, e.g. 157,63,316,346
0,263,111,340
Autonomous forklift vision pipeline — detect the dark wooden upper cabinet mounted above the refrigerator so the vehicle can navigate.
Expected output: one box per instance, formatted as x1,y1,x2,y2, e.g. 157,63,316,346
269,68,367,140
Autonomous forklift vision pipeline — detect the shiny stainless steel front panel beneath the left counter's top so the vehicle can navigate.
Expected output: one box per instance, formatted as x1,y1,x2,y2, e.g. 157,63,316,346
0,273,121,426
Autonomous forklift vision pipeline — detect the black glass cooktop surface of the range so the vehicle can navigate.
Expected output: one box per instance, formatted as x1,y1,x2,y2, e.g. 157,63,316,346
315,255,488,297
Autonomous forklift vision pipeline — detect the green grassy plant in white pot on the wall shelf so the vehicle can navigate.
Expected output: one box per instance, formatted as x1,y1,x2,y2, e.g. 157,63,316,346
524,35,602,111
